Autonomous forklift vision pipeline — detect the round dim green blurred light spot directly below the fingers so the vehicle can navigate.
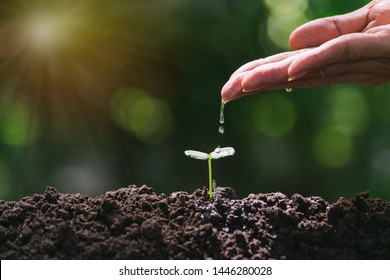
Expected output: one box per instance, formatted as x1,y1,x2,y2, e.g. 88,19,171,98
253,94,297,137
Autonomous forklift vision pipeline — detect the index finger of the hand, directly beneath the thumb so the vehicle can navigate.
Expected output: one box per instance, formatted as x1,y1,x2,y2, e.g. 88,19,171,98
288,32,390,80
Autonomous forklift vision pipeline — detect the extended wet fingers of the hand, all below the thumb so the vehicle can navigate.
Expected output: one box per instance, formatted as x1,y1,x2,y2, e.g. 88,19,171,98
221,19,390,102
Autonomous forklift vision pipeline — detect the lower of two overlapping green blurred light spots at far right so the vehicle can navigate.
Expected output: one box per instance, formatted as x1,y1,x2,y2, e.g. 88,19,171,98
313,126,353,168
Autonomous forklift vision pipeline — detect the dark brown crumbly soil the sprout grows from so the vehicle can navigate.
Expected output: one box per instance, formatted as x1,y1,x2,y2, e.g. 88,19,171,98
0,186,390,259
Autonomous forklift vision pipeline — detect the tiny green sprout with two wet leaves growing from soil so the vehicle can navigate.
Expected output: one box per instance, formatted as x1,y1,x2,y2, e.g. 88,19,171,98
184,146,235,200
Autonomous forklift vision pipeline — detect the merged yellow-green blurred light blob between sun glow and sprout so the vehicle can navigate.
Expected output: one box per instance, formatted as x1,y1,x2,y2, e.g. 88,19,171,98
111,88,173,144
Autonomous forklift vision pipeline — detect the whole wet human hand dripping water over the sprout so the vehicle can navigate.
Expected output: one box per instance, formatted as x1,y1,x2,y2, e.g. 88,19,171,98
221,0,390,102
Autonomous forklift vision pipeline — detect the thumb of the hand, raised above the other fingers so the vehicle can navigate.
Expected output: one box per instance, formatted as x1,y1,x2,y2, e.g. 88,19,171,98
290,5,369,50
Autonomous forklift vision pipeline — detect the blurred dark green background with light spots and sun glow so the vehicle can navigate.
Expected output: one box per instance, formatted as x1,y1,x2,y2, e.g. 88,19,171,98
0,0,390,201
